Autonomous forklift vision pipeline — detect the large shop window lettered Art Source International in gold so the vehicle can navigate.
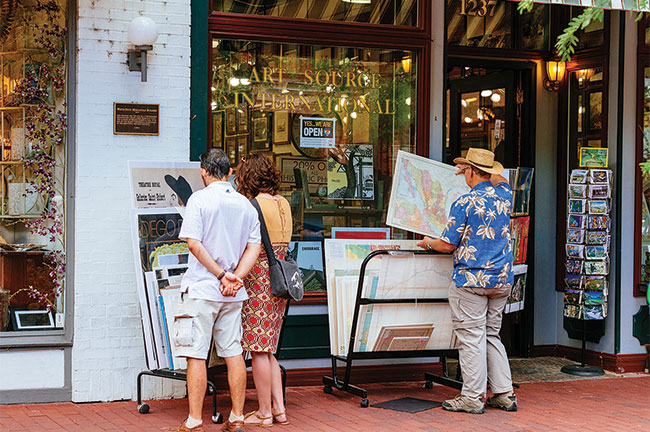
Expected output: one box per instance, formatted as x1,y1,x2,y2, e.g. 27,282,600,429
211,39,417,290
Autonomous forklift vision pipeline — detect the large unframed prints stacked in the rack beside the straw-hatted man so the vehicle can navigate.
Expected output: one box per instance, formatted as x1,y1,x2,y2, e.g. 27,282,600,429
325,239,454,355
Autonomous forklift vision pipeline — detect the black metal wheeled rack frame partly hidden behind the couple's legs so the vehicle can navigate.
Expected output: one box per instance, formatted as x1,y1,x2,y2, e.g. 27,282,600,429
137,300,291,424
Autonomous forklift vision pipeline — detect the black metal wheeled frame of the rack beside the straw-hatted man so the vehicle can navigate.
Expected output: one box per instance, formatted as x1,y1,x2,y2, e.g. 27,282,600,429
323,250,463,408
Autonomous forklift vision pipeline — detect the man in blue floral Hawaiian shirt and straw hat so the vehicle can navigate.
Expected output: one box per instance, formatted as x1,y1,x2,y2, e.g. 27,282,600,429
418,148,517,414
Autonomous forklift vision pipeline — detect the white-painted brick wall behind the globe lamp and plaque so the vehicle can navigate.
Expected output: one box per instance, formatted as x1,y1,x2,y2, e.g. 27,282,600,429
71,0,190,402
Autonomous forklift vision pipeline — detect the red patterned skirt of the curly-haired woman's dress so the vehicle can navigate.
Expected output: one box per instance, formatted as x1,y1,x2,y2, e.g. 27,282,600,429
241,243,289,353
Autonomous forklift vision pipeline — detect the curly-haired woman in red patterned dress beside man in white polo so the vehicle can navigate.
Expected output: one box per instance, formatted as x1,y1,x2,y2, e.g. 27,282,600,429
237,154,293,426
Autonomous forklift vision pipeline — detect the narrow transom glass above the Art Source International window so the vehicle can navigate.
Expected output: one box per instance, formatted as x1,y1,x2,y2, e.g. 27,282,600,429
213,0,419,26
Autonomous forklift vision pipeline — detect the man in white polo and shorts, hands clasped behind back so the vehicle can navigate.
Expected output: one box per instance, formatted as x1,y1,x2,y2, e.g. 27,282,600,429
172,149,261,432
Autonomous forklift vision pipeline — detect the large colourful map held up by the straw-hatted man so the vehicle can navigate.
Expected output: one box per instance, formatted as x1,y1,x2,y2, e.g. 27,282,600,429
386,150,469,237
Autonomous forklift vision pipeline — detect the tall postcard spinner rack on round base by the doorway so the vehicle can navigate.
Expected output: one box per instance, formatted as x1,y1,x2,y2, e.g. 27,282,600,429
562,168,612,376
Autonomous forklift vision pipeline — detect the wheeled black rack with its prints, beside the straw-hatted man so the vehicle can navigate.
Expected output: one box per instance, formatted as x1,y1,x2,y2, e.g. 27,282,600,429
323,245,462,408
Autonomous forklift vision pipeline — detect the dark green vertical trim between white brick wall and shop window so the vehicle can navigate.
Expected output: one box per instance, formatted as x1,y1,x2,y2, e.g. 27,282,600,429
190,0,210,161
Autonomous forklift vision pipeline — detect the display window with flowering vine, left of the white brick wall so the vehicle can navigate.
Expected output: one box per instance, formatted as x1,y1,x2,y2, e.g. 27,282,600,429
0,1,66,332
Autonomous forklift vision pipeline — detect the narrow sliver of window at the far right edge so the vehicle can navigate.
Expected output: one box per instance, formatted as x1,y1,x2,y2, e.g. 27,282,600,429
637,66,650,286
